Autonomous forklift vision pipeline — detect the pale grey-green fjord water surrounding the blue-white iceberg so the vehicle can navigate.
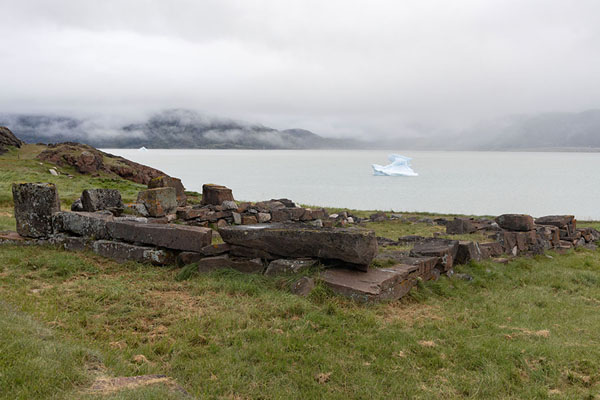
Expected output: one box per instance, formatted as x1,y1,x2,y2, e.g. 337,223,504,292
105,149,600,220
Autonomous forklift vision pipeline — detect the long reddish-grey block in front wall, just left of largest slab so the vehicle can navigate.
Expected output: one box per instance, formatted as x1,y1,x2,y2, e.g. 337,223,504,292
108,220,212,252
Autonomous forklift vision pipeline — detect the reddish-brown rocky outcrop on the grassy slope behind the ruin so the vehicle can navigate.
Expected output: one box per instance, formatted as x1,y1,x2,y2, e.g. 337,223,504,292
37,142,168,185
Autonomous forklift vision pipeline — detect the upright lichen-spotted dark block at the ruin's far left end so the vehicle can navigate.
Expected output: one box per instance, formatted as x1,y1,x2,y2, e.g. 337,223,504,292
12,183,60,238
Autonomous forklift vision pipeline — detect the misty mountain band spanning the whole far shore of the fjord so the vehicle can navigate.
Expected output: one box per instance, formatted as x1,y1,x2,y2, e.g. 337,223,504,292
0,109,600,151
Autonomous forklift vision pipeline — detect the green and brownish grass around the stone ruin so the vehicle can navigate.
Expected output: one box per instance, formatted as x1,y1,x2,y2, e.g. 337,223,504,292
0,143,600,399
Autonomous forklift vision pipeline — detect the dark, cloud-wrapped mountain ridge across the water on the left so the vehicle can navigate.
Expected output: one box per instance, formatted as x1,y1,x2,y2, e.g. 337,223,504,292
0,109,355,149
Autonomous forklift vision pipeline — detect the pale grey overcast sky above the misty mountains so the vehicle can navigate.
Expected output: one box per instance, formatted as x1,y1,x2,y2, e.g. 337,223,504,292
0,0,600,138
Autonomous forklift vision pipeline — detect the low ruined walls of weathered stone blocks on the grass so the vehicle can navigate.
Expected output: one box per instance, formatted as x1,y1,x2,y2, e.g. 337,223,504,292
0,178,600,302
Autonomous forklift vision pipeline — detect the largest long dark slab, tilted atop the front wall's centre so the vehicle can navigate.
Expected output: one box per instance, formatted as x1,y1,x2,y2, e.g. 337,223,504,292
219,223,377,270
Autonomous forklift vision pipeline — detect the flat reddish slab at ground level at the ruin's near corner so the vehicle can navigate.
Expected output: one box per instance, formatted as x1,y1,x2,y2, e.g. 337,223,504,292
320,265,418,302
